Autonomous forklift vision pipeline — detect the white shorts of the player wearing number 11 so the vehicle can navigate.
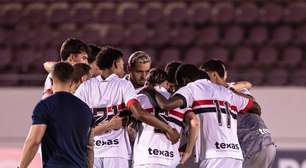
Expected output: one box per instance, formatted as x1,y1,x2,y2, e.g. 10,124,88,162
199,158,242,168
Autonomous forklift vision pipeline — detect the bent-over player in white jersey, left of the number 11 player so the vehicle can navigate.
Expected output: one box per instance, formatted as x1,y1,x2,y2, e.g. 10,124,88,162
133,69,199,168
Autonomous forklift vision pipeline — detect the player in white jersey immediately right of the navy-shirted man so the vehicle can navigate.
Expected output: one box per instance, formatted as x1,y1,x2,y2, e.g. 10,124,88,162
75,47,179,168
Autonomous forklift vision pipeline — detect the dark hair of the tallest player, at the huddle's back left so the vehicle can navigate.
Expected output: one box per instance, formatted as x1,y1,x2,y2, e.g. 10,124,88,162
60,38,89,61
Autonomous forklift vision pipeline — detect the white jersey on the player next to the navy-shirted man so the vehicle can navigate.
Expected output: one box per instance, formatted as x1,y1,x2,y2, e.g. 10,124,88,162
75,74,137,159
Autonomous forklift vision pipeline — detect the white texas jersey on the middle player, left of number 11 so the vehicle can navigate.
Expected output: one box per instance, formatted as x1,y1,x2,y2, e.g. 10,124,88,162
133,87,189,167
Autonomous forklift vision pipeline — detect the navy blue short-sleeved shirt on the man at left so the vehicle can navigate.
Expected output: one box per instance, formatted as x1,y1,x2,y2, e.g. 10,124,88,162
32,92,93,168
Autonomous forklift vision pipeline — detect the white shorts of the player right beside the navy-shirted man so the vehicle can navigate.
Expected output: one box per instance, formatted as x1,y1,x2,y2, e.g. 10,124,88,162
93,157,130,168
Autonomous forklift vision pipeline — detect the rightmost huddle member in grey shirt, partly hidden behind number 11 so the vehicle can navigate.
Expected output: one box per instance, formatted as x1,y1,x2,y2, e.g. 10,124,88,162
201,60,276,168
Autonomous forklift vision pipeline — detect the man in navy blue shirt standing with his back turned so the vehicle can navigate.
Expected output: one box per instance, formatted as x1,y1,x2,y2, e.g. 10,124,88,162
20,62,93,168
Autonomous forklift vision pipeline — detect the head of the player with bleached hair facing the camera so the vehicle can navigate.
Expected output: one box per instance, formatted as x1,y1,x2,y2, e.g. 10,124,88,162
125,51,152,93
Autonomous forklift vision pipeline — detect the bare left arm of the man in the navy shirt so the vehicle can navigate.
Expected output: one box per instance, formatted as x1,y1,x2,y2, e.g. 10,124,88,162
19,124,47,168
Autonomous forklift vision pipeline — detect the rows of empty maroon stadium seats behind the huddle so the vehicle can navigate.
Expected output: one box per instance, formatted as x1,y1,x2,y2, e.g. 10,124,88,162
0,0,306,86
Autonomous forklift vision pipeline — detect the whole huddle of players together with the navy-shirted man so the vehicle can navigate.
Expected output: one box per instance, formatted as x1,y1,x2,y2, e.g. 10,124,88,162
19,39,276,168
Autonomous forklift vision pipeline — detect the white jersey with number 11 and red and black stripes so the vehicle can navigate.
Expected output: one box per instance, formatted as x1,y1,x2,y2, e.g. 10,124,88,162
175,79,253,161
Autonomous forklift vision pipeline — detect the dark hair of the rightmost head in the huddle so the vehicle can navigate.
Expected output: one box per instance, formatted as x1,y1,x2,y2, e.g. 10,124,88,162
200,60,226,78
